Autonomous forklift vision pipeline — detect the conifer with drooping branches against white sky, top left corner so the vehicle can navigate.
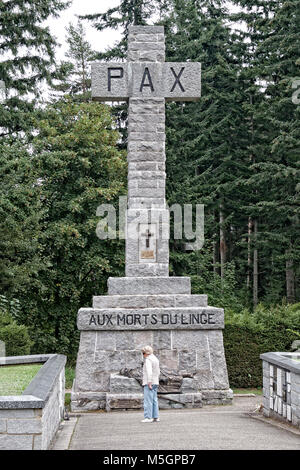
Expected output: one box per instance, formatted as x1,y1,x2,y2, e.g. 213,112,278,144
0,0,67,135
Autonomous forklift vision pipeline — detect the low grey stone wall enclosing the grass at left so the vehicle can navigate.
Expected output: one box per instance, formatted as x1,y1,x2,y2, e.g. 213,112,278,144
0,354,66,450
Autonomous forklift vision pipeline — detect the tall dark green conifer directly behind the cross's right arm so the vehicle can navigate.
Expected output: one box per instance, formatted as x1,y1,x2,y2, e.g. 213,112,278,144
165,0,247,294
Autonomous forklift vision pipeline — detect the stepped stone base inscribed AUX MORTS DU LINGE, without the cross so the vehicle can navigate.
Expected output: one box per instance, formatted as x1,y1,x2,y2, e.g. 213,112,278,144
71,277,232,411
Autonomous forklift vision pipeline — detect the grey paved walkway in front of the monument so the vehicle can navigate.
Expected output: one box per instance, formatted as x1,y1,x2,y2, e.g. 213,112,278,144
53,396,300,450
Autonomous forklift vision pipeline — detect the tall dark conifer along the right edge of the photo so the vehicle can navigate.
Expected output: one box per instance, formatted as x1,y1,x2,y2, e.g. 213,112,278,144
236,1,300,301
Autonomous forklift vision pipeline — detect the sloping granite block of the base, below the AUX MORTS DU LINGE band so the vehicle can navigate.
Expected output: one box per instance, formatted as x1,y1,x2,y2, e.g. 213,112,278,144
71,330,232,411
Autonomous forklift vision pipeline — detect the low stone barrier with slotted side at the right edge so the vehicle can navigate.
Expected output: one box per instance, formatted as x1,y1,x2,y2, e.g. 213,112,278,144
260,352,300,428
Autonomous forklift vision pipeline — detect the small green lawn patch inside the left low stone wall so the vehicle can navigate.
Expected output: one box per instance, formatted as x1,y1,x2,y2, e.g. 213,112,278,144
0,363,43,395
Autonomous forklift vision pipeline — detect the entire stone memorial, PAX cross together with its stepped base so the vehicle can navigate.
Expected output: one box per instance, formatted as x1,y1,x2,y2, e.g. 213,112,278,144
71,26,232,411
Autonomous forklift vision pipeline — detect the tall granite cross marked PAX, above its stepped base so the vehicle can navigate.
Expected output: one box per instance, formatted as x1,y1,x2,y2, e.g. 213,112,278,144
92,26,201,277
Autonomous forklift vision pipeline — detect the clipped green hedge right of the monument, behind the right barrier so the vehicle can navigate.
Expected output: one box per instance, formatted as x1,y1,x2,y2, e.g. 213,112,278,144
224,304,300,388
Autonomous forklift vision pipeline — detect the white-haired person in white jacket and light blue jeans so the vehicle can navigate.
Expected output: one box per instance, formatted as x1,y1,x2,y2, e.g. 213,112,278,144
142,346,160,423
